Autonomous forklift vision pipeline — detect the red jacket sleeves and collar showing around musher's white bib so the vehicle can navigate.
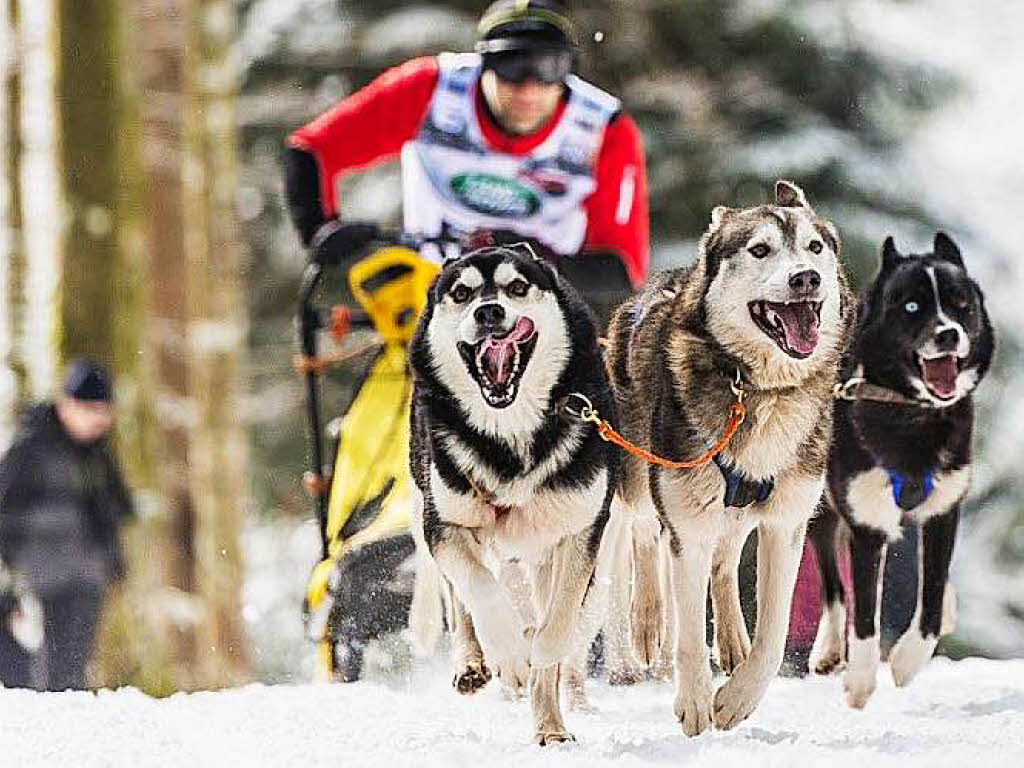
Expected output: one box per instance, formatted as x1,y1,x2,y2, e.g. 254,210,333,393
289,57,648,286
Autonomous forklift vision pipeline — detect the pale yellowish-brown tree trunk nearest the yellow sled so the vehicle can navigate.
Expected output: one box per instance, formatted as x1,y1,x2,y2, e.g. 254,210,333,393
183,0,248,685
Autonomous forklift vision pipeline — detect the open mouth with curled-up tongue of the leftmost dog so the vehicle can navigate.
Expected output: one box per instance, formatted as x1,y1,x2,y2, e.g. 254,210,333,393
459,316,537,408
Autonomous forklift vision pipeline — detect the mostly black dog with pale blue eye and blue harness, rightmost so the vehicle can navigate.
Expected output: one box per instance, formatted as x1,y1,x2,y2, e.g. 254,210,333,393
810,232,993,709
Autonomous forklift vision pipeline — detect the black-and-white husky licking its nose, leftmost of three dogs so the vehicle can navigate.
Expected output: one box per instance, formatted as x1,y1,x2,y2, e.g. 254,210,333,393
411,246,617,744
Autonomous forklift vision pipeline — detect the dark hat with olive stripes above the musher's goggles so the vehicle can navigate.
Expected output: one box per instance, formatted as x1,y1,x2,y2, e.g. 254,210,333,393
476,0,575,53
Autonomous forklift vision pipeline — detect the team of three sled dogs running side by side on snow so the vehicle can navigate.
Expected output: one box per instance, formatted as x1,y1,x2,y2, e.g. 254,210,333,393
411,181,993,744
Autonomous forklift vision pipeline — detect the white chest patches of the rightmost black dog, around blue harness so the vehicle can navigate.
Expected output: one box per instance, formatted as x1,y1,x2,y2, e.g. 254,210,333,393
846,467,971,541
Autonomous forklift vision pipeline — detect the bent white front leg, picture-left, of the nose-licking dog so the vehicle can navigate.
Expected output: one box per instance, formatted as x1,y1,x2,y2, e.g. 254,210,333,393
431,523,529,695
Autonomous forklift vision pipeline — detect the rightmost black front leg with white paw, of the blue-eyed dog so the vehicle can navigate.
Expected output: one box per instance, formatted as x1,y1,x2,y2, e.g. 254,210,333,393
889,505,959,686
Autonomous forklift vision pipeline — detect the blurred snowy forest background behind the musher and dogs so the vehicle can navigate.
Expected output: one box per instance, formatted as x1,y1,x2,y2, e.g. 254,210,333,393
0,0,1024,693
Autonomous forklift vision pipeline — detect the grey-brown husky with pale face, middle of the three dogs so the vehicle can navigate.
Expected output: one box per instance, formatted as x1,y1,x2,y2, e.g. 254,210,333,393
608,181,854,735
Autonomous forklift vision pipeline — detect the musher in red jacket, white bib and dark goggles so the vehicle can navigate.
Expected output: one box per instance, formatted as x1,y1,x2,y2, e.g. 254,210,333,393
286,0,648,292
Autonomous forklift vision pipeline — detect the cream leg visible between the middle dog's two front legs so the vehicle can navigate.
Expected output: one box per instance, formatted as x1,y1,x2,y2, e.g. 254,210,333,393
711,513,755,675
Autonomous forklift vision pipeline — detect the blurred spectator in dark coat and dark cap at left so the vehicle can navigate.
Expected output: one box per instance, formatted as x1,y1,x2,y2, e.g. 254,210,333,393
0,360,133,690
